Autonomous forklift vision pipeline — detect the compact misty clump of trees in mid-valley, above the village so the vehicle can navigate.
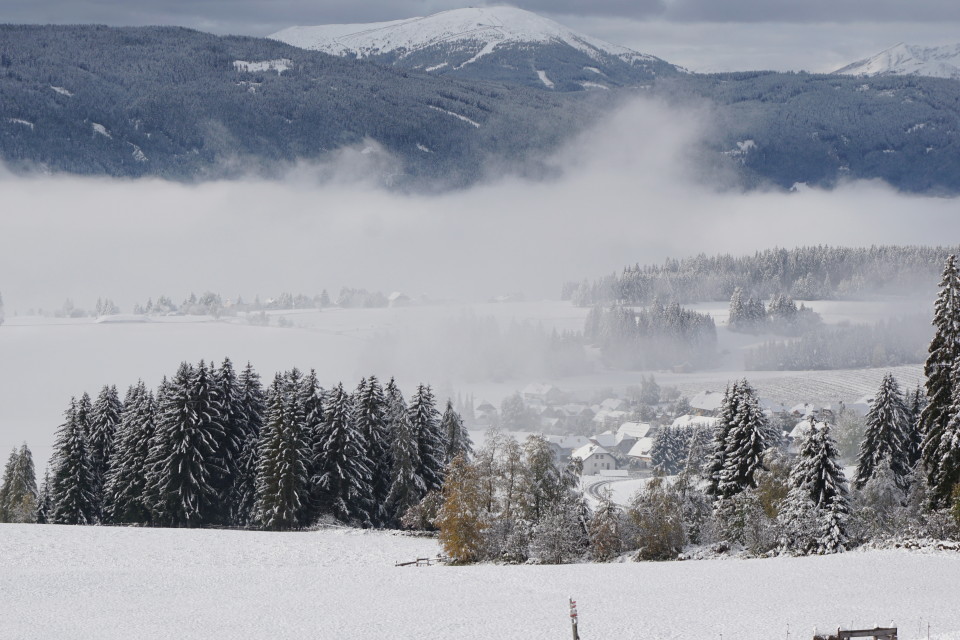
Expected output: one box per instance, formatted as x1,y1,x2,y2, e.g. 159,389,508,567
583,300,717,369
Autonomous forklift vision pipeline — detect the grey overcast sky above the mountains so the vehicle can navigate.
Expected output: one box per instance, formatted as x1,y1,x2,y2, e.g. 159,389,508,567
0,0,960,72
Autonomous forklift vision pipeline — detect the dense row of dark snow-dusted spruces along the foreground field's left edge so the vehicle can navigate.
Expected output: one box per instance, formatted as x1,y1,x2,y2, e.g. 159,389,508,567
37,359,471,530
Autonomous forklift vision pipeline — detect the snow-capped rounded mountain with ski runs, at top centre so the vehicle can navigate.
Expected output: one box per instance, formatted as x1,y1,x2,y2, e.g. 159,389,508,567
269,7,683,91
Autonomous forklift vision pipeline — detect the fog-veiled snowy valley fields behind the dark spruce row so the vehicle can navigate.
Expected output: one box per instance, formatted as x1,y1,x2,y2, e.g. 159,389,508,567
0,301,922,468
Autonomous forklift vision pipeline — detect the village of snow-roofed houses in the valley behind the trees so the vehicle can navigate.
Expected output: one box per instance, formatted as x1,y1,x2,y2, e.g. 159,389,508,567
461,376,872,477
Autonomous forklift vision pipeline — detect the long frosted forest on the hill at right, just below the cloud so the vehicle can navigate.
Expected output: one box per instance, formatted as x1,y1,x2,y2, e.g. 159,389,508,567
561,245,958,306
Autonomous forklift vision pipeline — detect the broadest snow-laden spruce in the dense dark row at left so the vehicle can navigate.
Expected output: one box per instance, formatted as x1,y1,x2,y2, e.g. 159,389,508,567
147,362,223,527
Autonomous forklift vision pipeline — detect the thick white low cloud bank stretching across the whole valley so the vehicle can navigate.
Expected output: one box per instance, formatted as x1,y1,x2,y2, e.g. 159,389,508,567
0,96,960,313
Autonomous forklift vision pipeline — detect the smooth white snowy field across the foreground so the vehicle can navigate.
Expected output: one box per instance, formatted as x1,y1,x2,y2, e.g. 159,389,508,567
0,525,960,640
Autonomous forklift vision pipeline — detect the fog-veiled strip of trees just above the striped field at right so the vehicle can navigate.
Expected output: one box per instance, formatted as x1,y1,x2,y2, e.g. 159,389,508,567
744,315,931,371
